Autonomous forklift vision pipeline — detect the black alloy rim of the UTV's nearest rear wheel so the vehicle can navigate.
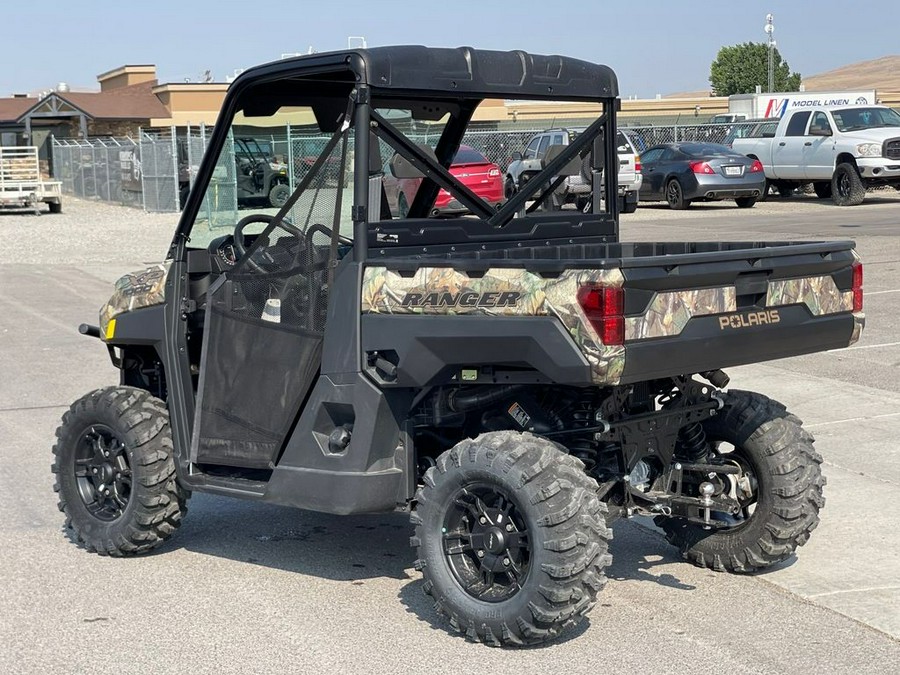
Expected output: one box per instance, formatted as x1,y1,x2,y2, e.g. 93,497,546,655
443,484,531,602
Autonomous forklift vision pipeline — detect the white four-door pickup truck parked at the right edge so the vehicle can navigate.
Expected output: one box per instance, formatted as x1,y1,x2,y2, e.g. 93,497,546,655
732,105,900,206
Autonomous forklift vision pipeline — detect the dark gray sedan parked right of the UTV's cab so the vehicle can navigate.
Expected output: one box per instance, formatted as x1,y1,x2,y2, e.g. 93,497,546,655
640,143,766,209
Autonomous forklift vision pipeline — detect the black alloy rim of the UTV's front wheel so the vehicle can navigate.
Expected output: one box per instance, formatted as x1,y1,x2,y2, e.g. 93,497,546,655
75,424,131,522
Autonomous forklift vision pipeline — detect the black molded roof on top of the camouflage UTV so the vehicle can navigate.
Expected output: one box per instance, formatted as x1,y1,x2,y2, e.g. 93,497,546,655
233,46,619,101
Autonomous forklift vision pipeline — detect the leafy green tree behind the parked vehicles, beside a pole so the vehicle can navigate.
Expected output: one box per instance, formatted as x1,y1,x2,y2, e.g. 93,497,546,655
709,42,800,96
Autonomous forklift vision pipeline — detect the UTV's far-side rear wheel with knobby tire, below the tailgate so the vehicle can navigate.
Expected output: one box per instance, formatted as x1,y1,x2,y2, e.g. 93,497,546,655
656,390,825,572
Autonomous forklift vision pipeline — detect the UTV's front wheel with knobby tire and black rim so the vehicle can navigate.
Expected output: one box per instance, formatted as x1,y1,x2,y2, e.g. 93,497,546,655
52,387,190,556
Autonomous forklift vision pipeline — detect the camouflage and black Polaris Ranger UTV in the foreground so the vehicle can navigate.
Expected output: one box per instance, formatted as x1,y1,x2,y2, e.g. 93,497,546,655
53,47,863,645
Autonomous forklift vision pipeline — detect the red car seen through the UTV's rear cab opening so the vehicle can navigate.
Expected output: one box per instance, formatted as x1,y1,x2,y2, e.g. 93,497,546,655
384,145,504,218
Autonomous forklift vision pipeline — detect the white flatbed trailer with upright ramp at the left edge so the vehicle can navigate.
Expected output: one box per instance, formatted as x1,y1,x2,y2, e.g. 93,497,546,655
0,147,62,213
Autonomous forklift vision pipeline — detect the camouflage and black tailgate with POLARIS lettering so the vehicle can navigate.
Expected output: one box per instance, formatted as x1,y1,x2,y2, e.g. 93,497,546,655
620,242,864,383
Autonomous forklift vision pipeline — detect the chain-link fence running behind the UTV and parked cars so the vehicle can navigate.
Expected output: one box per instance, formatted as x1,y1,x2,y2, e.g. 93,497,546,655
53,119,777,211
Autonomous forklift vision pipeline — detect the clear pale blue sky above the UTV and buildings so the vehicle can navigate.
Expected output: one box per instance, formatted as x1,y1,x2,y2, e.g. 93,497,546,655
0,0,900,97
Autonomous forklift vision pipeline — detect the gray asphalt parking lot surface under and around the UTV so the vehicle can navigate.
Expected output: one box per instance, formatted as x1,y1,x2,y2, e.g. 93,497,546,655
0,191,900,675
